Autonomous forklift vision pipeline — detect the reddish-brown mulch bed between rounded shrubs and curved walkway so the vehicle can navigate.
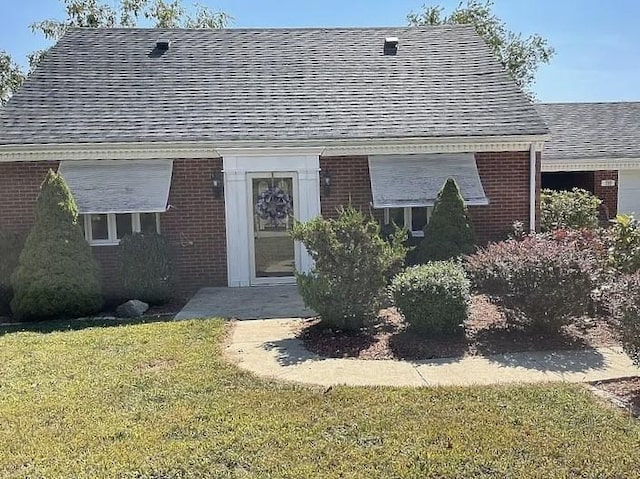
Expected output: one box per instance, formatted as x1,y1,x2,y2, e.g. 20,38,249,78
297,295,619,359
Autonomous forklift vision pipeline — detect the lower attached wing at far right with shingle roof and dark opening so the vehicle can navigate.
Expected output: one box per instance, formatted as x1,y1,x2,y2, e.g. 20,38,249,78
536,102,640,219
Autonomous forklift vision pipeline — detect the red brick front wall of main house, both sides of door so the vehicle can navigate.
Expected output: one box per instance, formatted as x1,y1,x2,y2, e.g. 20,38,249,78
0,152,536,297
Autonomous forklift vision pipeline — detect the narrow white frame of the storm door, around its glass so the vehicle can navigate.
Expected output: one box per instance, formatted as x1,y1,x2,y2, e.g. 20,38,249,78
246,171,301,286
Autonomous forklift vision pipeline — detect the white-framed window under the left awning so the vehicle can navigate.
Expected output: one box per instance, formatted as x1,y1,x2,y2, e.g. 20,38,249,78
78,213,160,246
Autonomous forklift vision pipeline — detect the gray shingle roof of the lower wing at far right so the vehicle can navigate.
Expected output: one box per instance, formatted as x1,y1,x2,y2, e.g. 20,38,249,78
536,102,640,162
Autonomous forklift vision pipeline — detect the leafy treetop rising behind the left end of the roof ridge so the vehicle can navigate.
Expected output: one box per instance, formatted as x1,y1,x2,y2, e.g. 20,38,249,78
29,0,231,68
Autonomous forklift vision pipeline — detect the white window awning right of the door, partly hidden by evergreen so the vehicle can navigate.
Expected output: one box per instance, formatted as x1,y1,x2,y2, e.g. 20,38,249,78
369,153,489,208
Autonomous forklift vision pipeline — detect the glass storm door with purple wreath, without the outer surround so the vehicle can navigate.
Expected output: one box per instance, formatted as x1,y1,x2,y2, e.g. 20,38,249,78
248,172,298,284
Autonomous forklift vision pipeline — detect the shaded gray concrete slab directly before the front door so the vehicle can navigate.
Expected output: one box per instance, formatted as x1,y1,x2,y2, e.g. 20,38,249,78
175,284,315,319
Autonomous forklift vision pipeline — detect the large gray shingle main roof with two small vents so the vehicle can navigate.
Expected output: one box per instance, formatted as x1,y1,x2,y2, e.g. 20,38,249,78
0,26,547,145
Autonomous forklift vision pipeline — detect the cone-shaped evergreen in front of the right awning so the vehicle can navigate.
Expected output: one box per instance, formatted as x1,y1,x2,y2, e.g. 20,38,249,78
418,178,476,263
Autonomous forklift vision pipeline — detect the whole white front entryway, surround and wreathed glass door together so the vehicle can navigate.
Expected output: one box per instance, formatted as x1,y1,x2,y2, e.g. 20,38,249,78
222,154,320,288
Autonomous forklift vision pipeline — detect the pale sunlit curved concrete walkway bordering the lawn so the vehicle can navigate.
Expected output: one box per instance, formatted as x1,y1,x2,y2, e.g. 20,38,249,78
227,319,640,386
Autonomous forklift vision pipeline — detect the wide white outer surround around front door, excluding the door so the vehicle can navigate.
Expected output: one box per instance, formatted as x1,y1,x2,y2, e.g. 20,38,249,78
222,156,320,287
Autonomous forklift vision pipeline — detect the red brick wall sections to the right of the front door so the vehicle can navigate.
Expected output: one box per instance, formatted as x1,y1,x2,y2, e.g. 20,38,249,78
320,151,540,242
